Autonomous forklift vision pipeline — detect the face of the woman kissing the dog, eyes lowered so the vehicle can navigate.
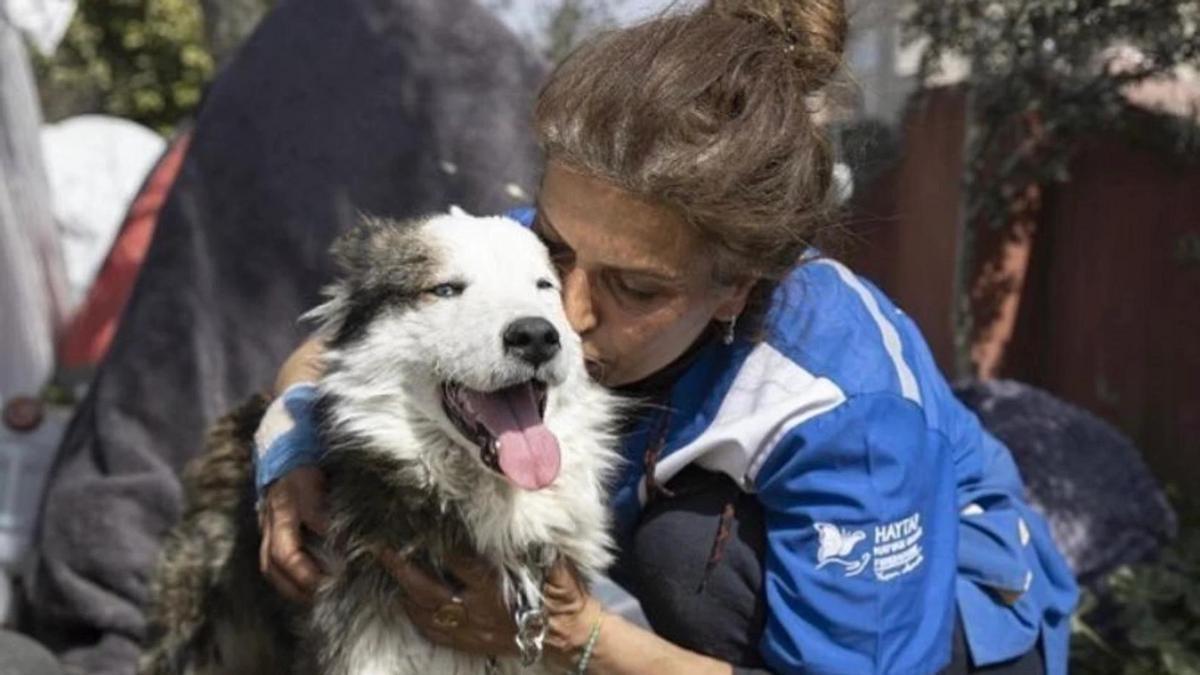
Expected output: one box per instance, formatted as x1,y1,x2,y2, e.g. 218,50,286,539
534,161,751,387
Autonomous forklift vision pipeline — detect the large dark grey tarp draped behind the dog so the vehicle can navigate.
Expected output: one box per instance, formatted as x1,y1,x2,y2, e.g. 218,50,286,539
22,0,544,675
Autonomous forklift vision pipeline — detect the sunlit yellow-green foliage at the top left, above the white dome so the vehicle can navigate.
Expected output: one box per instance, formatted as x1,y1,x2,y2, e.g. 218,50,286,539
35,0,214,133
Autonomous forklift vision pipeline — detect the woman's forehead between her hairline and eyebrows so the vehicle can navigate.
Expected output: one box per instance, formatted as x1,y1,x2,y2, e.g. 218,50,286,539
539,162,702,279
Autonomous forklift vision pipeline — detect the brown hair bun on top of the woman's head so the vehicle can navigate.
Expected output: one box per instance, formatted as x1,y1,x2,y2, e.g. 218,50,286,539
709,0,847,83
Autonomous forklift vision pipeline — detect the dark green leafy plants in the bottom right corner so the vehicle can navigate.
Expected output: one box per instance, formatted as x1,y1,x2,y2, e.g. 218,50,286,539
1072,497,1200,675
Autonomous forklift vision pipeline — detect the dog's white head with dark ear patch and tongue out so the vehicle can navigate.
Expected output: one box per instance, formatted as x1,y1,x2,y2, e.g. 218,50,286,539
308,209,587,490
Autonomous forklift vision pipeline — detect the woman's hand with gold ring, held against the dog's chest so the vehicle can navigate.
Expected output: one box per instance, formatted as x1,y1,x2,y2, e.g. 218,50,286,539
380,551,601,665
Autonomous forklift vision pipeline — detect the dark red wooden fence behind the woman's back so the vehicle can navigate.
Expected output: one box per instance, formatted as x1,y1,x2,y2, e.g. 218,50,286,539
847,91,1200,491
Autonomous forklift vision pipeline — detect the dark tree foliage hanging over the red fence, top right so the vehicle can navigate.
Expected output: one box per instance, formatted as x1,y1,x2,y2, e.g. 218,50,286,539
908,0,1200,225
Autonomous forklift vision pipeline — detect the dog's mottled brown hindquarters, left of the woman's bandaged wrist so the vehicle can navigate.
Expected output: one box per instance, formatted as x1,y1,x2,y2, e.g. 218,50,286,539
138,398,288,675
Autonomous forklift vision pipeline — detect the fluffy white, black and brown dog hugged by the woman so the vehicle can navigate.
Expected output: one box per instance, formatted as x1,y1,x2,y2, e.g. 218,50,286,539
139,210,618,675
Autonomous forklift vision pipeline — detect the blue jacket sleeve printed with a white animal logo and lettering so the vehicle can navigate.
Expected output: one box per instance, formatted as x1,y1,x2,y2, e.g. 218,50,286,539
752,394,958,674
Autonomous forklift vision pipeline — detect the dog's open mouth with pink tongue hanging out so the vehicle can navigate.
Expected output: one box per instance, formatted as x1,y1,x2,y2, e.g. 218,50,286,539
463,384,559,490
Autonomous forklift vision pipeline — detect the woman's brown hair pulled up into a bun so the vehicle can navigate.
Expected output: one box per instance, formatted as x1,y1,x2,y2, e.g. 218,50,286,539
535,0,847,329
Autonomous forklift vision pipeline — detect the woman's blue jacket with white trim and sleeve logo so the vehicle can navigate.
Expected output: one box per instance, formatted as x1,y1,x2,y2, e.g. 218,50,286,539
259,210,1076,675
